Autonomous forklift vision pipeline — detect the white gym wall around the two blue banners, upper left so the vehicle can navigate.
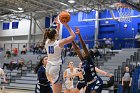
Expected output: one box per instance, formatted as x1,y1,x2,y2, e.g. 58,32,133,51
0,18,45,48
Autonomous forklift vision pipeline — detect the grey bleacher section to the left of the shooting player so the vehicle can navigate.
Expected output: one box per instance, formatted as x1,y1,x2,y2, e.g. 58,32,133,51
0,53,44,90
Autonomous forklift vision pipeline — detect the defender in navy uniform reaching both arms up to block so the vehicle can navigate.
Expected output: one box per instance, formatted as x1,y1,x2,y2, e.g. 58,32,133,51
72,28,112,93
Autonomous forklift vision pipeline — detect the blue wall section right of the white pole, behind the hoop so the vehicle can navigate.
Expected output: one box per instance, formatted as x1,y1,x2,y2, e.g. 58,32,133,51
99,10,140,49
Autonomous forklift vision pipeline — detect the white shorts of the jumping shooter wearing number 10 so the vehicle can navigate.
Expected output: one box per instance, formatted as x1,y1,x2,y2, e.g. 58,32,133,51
46,63,63,84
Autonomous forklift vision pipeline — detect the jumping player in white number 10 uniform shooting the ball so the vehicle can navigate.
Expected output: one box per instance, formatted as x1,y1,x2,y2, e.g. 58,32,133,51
44,18,75,93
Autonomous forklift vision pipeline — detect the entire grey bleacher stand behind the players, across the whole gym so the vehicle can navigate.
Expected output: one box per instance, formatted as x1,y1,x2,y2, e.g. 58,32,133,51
0,49,140,93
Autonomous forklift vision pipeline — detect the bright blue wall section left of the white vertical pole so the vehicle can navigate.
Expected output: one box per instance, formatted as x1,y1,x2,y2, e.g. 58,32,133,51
62,11,95,48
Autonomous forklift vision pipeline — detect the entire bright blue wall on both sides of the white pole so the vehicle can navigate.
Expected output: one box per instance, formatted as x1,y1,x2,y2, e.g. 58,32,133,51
45,10,140,49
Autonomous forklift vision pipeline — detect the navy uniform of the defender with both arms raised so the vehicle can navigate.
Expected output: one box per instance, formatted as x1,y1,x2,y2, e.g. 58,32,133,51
82,56,103,93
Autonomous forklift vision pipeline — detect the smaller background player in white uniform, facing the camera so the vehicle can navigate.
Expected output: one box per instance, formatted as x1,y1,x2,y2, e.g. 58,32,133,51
63,62,77,93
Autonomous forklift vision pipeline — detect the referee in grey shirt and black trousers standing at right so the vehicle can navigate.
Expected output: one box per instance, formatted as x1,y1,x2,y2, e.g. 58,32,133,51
122,66,132,93
